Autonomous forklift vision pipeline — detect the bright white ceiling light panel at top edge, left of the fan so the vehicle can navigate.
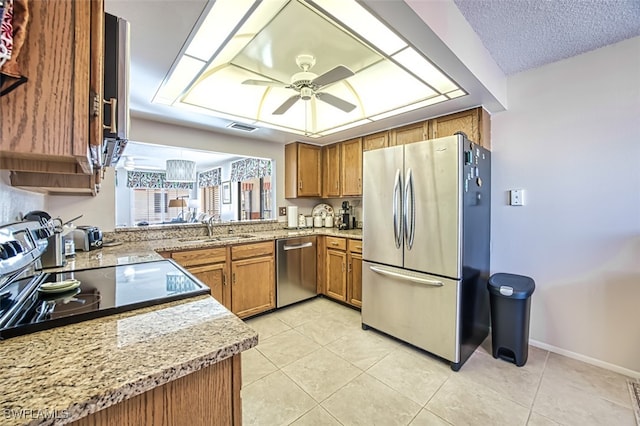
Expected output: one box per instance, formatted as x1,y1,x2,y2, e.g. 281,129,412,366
185,0,254,61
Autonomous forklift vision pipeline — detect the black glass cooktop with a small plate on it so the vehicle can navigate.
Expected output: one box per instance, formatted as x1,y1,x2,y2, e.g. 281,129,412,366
0,259,210,339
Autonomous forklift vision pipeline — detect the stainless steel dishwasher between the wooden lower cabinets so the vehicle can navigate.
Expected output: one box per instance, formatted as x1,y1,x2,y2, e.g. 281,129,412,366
276,236,318,308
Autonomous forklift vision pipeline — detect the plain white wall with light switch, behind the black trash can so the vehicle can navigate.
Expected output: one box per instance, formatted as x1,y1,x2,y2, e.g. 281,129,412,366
491,37,640,376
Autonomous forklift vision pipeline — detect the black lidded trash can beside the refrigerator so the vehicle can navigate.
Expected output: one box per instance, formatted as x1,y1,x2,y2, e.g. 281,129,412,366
487,273,536,367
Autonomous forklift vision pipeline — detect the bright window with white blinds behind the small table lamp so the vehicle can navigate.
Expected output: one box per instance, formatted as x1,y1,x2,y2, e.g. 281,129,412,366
133,188,191,223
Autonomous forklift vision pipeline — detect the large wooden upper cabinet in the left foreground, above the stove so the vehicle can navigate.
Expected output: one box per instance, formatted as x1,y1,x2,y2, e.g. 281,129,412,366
0,0,104,176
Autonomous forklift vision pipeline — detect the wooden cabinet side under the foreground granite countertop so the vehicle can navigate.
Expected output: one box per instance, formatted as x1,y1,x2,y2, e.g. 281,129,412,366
70,354,242,426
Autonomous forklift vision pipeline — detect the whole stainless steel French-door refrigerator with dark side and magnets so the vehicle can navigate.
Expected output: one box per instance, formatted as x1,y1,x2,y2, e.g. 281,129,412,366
362,134,491,371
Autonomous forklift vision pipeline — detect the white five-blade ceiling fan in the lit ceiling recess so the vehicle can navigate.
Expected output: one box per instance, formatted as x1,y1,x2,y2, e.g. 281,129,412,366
242,55,356,115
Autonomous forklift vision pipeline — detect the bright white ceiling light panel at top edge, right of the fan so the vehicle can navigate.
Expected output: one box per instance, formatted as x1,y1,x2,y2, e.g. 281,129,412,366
314,0,407,55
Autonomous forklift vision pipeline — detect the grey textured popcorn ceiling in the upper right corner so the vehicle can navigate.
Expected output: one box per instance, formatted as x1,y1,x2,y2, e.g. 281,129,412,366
454,0,640,75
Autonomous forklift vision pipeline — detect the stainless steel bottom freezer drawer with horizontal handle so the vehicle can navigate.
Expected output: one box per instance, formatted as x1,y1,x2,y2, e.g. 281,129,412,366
362,262,460,362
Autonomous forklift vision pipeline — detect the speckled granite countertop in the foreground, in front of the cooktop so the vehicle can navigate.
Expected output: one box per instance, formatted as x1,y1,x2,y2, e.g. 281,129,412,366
0,296,258,425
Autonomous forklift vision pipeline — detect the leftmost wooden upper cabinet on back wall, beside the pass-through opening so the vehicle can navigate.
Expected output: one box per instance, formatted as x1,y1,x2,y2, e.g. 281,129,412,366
284,142,322,198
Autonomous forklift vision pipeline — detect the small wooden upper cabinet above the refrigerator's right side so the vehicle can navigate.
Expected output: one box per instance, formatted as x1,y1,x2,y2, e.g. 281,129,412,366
429,107,491,149
